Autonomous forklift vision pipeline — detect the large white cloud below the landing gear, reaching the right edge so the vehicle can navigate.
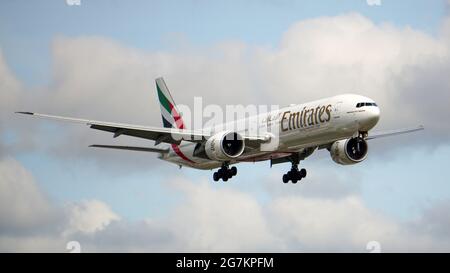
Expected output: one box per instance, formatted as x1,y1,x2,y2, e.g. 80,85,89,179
91,179,450,252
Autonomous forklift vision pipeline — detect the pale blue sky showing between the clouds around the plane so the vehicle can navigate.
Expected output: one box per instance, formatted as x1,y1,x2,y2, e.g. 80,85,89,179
0,0,450,251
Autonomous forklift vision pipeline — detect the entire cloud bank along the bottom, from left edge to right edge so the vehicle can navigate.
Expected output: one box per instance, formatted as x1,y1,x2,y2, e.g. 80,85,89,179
0,160,450,252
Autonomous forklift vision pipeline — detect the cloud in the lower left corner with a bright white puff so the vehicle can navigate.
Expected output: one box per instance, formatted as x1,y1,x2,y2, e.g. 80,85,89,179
0,158,119,252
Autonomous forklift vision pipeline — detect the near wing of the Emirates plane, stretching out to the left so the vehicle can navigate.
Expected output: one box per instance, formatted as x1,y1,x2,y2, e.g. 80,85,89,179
16,112,268,145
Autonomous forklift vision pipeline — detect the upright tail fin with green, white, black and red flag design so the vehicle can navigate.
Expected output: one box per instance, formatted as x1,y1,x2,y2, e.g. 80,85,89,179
155,75,185,129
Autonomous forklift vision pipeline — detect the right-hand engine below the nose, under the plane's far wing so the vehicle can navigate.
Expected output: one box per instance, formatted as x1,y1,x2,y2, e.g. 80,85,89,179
330,137,369,165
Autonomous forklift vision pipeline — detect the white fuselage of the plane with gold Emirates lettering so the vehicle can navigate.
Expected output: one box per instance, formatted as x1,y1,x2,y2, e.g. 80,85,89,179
160,94,380,169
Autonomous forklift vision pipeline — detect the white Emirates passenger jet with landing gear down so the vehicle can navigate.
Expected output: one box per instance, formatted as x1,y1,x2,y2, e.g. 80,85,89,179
16,77,424,184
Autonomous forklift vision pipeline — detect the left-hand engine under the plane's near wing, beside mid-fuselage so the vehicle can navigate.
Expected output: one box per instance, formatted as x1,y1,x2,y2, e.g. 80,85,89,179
205,131,245,161
